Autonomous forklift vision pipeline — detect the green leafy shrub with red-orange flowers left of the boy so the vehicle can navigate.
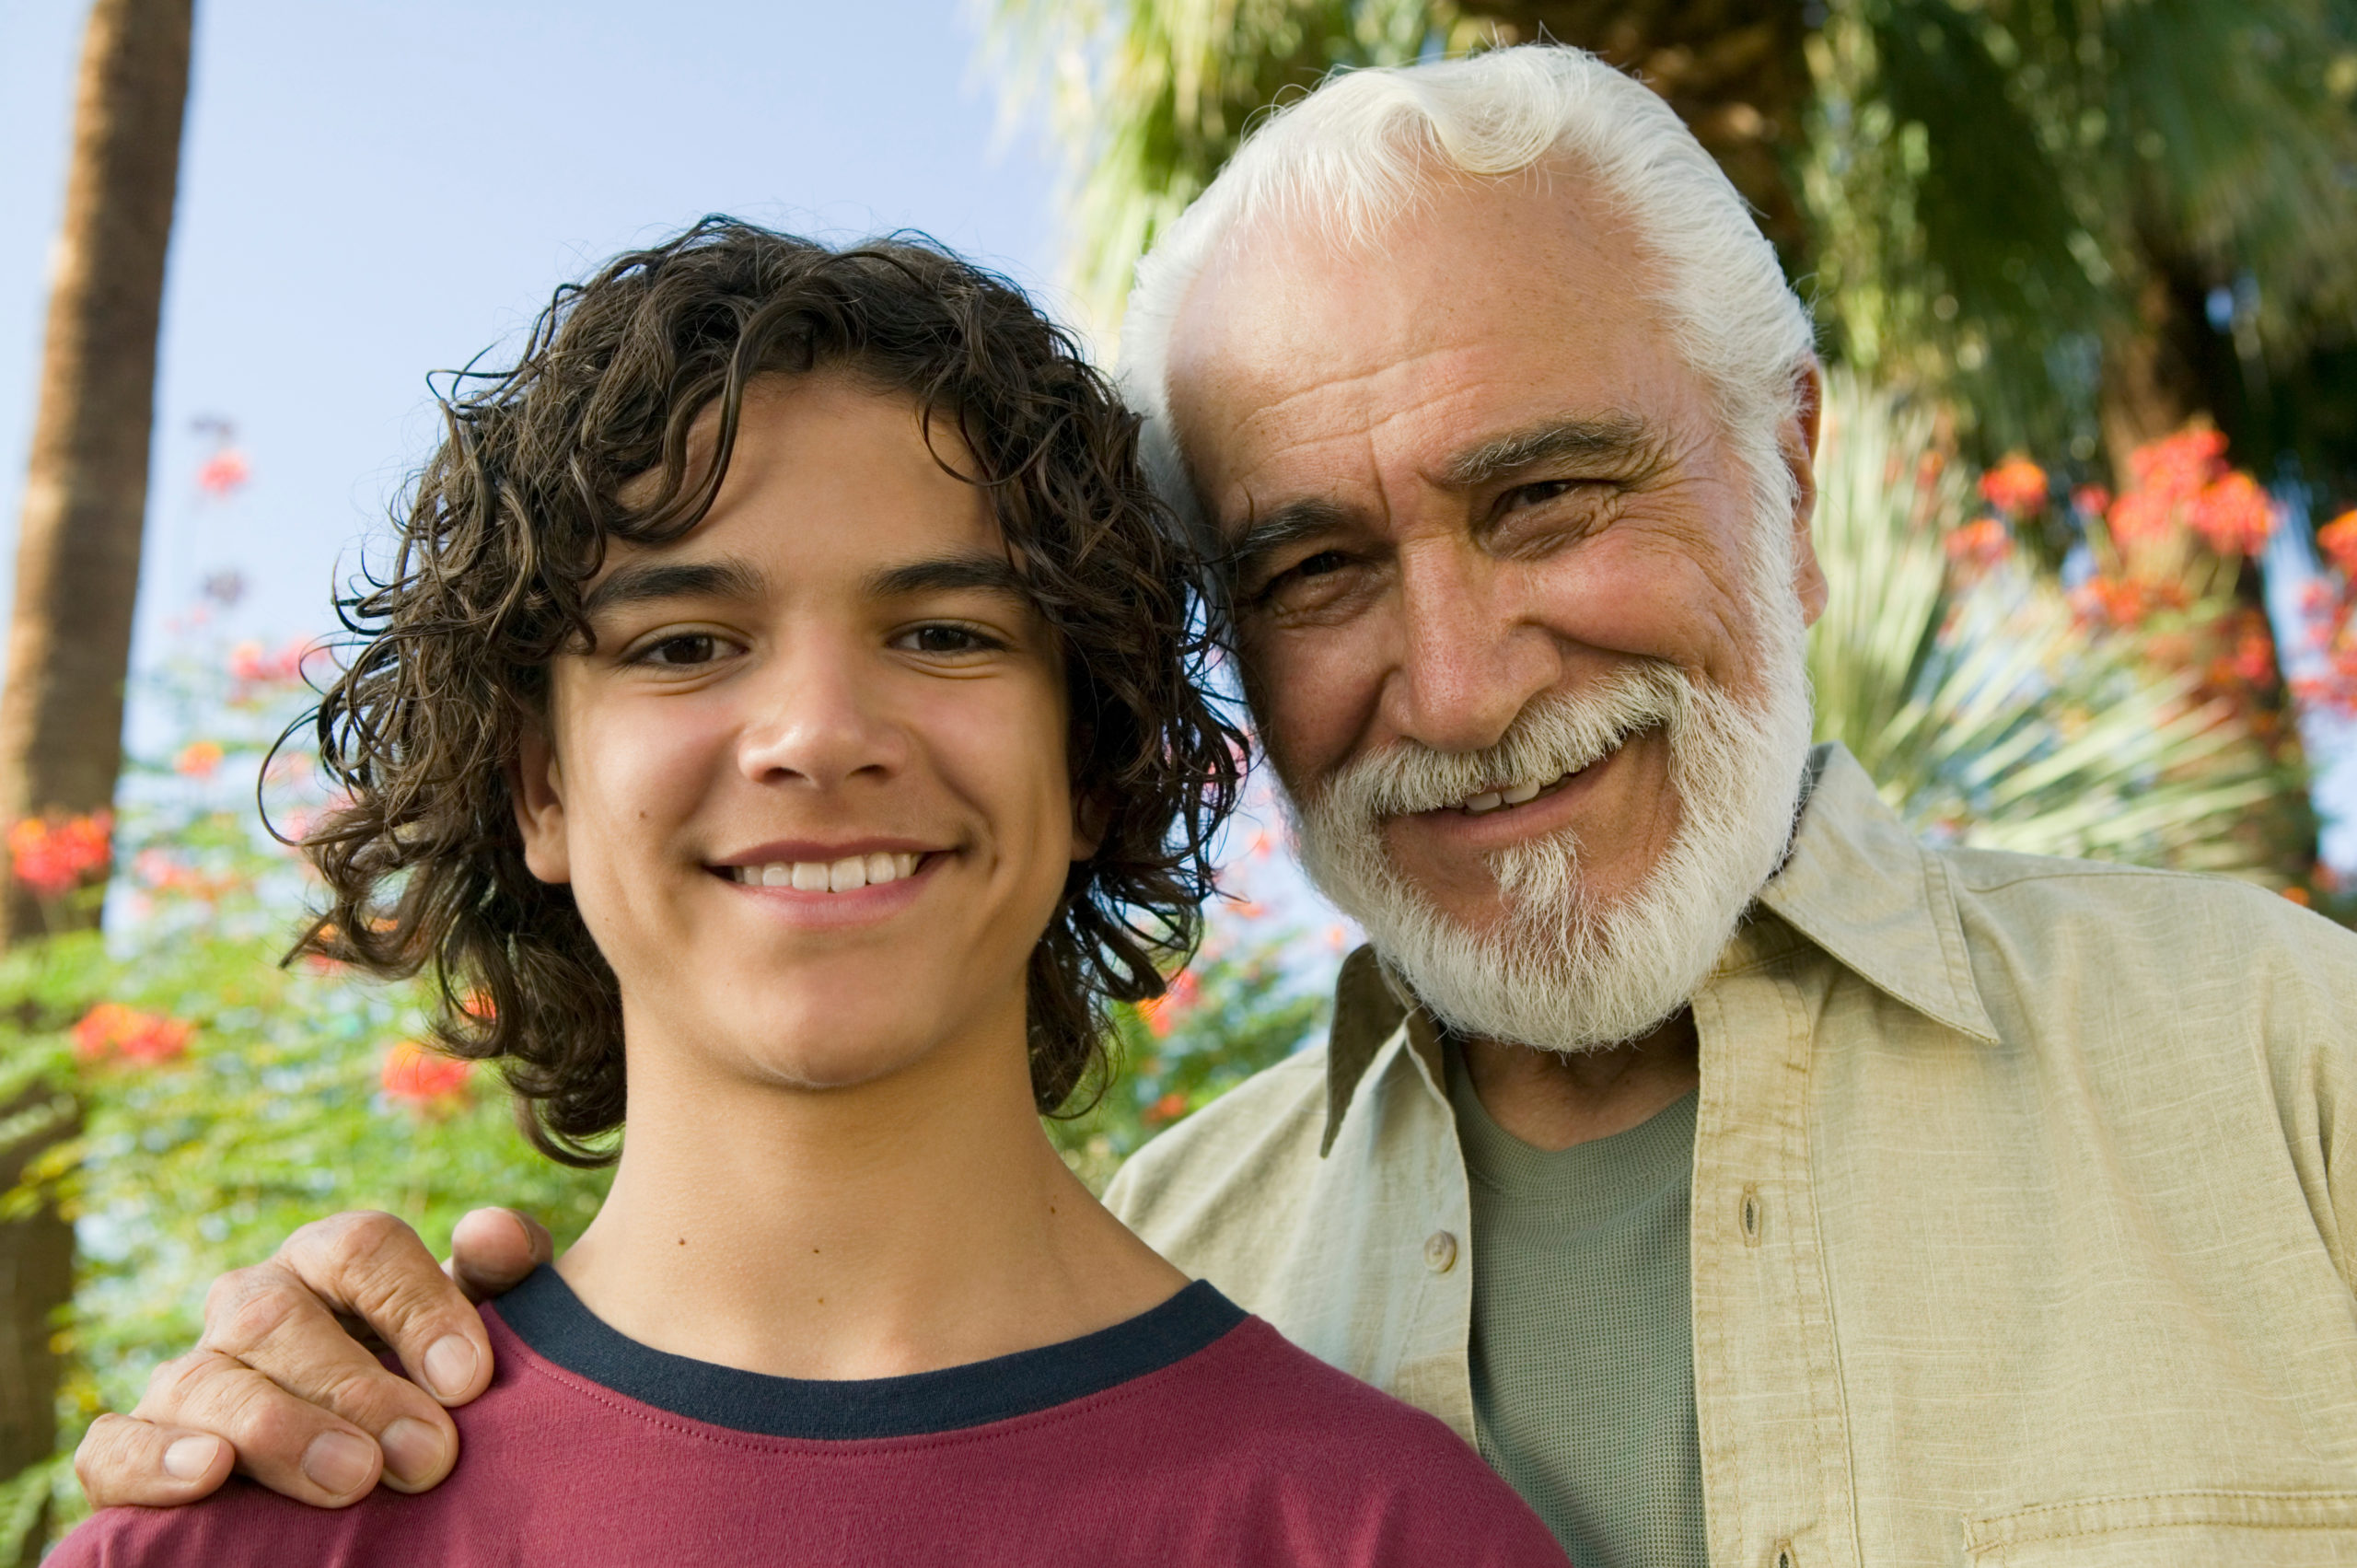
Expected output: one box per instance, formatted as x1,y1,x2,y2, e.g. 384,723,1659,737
0,641,603,1527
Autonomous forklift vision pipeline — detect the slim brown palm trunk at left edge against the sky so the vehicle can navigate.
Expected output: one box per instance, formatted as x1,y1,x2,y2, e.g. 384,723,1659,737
0,0,193,943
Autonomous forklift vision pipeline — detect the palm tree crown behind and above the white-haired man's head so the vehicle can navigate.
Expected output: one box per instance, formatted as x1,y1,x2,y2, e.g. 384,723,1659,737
994,0,2357,459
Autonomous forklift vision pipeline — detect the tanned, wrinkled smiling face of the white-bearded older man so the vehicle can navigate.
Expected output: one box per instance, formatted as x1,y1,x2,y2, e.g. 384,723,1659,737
1171,175,1822,1051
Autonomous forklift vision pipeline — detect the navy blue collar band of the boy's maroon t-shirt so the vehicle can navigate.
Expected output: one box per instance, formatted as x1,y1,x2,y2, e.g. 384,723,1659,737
493,1264,1245,1438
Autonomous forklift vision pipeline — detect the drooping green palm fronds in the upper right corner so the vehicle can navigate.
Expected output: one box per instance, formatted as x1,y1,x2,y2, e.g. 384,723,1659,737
1801,0,2357,446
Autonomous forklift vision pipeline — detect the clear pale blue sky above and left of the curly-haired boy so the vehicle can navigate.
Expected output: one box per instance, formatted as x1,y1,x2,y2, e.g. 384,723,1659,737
0,0,1056,660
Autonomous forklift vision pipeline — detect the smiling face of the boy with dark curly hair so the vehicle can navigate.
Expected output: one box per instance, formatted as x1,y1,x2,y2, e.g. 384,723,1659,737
517,373,1089,1089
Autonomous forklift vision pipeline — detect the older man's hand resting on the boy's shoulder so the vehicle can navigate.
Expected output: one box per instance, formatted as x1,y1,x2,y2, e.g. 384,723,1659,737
73,1210,554,1509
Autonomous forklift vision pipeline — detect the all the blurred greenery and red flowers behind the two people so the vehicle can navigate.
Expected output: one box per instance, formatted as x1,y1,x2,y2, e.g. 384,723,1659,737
0,0,2357,1556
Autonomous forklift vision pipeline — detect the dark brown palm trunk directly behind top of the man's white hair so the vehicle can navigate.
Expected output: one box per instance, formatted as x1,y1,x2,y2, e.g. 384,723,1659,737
1459,0,1810,276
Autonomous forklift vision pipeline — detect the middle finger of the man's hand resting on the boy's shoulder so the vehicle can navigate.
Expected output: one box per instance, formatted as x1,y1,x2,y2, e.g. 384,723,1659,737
192,1261,458,1493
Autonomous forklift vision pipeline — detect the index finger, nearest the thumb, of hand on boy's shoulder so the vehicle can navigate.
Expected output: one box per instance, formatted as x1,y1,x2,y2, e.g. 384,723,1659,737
265,1212,490,1405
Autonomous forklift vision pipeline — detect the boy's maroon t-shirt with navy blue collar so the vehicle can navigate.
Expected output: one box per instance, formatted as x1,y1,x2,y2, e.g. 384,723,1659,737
50,1269,1565,1568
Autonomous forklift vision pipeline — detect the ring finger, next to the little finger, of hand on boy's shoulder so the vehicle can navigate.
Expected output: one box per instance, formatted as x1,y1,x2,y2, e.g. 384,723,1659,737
131,1351,386,1509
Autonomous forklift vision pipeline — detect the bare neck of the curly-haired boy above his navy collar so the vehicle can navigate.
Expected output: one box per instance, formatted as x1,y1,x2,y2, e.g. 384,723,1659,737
556,1004,1186,1379
